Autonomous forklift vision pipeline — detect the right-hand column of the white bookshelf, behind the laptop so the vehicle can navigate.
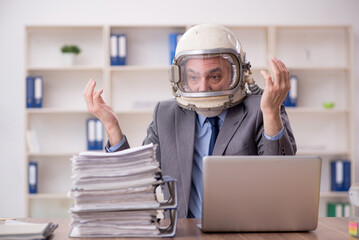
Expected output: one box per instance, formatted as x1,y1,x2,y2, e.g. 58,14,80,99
272,26,355,216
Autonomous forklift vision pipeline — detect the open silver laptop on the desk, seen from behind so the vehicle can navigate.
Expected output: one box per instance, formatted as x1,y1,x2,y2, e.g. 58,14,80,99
199,156,321,232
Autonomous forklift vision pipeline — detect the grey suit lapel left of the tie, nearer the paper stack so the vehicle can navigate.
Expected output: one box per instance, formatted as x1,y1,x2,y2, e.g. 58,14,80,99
175,107,196,210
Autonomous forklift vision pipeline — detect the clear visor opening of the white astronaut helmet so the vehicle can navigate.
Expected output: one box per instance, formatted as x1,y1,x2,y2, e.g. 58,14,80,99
178,53,240,93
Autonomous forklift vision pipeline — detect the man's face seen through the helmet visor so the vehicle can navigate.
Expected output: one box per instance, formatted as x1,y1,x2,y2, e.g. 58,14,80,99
185,56,231,92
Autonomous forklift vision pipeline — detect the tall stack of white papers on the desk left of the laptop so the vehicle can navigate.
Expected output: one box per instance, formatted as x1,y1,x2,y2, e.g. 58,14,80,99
70,144,177,237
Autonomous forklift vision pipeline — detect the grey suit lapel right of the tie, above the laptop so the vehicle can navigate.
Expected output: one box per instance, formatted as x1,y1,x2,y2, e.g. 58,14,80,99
213,104,247,155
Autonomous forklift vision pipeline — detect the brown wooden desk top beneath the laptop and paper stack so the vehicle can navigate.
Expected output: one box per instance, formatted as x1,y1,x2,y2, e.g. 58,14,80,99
18,218,358,240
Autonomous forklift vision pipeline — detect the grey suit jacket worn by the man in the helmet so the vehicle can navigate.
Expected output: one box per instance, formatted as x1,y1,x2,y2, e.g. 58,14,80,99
119,95,296,217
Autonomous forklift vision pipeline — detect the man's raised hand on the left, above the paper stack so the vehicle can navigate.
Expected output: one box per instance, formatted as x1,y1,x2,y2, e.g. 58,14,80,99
84,79,123,146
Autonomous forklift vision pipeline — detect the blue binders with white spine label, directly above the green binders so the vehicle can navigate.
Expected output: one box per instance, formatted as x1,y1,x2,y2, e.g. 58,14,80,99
330,160,351,191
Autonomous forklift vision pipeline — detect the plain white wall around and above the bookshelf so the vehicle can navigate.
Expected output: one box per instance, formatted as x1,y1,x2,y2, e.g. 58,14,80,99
0,0,359,217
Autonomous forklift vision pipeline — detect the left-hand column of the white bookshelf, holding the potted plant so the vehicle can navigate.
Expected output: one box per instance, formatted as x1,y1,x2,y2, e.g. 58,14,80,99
25,26,106,217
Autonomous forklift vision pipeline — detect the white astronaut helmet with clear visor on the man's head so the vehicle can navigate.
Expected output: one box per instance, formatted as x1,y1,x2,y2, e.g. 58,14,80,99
169,24,250,112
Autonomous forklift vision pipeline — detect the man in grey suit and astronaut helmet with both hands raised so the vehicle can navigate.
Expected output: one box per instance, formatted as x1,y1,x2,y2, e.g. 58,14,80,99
84,24,296,218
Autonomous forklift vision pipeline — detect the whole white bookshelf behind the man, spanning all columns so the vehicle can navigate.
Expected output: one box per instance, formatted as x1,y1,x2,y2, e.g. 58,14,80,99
24,25,355,217
